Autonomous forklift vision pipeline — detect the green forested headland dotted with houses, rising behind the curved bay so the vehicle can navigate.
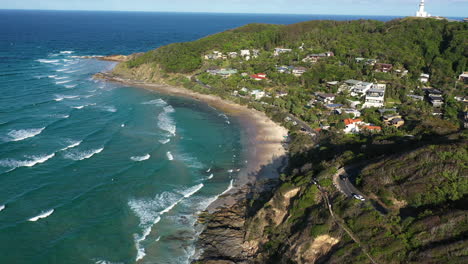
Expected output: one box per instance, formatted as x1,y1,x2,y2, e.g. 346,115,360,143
100,19,468,264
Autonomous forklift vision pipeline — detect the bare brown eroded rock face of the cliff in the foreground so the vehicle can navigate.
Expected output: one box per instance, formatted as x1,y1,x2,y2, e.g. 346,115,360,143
195,188,340,264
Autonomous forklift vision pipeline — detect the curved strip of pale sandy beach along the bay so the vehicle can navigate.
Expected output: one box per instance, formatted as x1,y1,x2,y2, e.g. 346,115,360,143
96,73,288,208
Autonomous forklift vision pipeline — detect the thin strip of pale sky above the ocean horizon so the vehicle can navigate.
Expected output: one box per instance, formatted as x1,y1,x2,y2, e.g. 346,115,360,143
0,0,468,17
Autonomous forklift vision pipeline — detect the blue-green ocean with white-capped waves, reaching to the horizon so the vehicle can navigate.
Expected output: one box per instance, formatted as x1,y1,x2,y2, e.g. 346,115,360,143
0,10,402,264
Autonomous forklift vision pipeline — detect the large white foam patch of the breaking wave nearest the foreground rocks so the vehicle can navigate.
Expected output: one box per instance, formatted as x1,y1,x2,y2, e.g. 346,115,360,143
128,184,203,261
